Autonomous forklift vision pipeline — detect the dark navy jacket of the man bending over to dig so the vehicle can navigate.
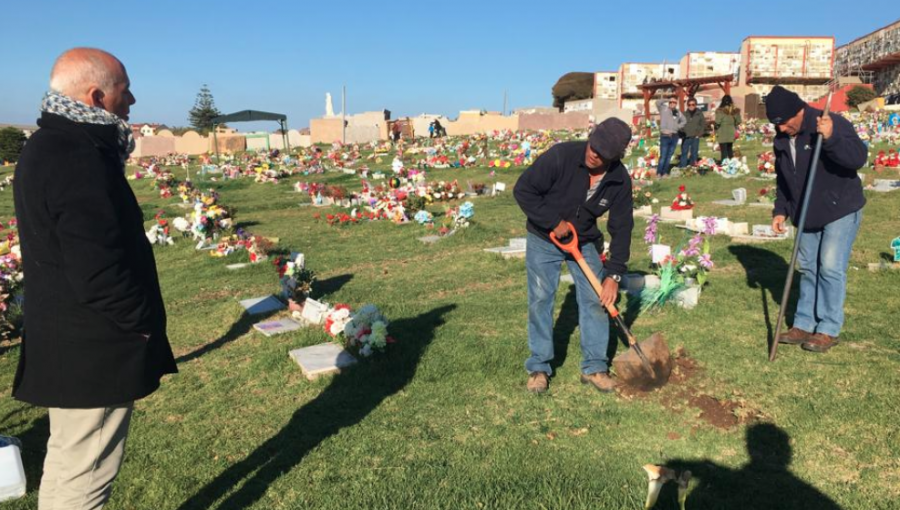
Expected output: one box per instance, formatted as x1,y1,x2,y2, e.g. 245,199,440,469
513,142,634,275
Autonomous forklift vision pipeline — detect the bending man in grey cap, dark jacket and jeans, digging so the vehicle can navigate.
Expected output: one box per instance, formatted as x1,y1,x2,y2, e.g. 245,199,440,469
513,118,634,393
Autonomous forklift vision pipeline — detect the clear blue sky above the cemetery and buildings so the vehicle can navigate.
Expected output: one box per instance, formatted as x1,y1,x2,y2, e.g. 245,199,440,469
0,0,900,129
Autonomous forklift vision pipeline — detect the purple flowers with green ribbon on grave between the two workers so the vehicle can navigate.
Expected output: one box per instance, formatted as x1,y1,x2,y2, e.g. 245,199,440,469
640,215,716,311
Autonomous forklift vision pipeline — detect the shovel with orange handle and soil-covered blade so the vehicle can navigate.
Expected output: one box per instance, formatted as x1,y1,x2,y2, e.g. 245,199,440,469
550,223,672,390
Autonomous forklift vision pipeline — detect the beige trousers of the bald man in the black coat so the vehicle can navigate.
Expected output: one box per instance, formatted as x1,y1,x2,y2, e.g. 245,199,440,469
38,402,134,510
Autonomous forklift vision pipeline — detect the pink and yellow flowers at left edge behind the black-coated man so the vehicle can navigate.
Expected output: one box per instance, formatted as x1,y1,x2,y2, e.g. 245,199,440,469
0,218,25,340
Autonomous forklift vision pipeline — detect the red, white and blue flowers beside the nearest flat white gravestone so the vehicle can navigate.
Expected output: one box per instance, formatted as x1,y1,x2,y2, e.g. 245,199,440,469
324,304,395,358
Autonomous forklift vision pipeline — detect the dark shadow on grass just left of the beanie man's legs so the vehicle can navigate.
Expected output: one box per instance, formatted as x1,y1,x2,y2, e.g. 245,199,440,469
728,244,800,352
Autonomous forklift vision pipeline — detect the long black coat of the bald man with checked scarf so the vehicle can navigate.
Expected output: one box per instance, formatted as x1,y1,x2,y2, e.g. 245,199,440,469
13,113,178,408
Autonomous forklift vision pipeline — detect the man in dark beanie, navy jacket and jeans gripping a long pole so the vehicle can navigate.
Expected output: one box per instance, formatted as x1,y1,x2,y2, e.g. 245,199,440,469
766,86,868,352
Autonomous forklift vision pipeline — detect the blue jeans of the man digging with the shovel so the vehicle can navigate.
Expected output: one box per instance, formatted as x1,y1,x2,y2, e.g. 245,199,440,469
525,233,609,375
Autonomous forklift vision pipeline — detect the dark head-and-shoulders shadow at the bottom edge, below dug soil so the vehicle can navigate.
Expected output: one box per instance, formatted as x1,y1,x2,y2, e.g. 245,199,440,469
657,423,841,510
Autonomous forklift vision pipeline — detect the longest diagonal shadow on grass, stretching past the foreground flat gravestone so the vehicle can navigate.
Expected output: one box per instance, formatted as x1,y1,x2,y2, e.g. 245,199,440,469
178,305,456,510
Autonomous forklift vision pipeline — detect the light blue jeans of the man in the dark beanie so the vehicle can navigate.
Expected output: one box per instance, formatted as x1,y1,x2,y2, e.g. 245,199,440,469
794,210,862,337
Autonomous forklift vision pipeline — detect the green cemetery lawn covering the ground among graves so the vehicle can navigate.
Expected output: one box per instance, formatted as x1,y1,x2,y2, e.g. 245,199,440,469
0,136,900,510
